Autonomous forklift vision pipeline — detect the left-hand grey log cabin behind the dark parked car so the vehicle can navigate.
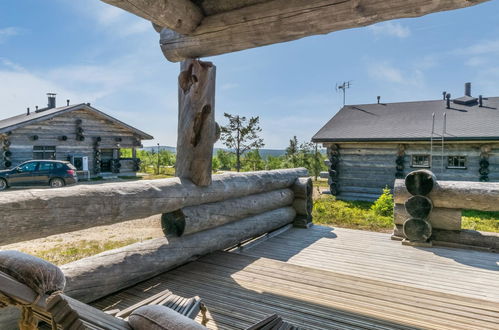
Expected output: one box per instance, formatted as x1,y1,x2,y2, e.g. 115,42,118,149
0,94,153,176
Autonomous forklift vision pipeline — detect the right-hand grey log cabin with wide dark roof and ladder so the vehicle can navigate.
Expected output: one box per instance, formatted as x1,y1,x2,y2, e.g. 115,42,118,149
312,83,499,201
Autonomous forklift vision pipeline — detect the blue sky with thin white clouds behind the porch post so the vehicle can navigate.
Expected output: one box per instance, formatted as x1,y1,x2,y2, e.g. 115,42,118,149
0,0,499,148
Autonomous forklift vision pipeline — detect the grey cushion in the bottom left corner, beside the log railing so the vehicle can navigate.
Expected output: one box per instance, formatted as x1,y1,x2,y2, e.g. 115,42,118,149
0,251,66,295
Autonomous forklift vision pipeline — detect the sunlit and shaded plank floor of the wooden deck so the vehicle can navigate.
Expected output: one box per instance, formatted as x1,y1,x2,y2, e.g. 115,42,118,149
94,226,499,329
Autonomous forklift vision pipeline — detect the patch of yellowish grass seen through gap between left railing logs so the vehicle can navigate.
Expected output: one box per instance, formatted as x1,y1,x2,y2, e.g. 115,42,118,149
23,239,140,265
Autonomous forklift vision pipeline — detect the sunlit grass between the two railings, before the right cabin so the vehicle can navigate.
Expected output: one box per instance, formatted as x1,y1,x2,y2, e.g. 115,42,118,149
313,195,393,232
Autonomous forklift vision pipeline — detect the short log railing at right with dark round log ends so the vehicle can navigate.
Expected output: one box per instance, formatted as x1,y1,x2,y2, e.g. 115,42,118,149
392,170,499,250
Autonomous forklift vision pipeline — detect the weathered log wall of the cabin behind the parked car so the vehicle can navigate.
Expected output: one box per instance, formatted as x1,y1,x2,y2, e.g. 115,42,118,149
0,109,146,174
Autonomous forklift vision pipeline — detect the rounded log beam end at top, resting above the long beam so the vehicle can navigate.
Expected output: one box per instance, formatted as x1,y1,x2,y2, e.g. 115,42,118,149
102,0,204,34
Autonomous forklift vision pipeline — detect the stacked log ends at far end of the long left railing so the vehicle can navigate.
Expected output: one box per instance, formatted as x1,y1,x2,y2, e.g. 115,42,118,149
292,178,314,228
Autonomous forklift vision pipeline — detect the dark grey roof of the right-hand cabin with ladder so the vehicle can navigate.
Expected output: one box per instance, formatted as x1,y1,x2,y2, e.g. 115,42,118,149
312,97,499,142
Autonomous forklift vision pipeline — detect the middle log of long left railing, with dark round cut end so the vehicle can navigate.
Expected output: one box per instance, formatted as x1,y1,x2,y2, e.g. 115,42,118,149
161,189,293,236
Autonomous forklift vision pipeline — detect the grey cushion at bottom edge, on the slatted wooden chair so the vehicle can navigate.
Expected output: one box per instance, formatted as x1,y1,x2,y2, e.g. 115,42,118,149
128,305,207,330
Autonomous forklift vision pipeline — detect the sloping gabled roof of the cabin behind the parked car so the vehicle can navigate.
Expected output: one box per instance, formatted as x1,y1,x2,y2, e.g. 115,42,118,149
0,103,154,140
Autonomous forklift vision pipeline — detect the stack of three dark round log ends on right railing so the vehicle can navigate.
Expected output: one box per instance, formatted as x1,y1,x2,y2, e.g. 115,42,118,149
394,170,437,244
